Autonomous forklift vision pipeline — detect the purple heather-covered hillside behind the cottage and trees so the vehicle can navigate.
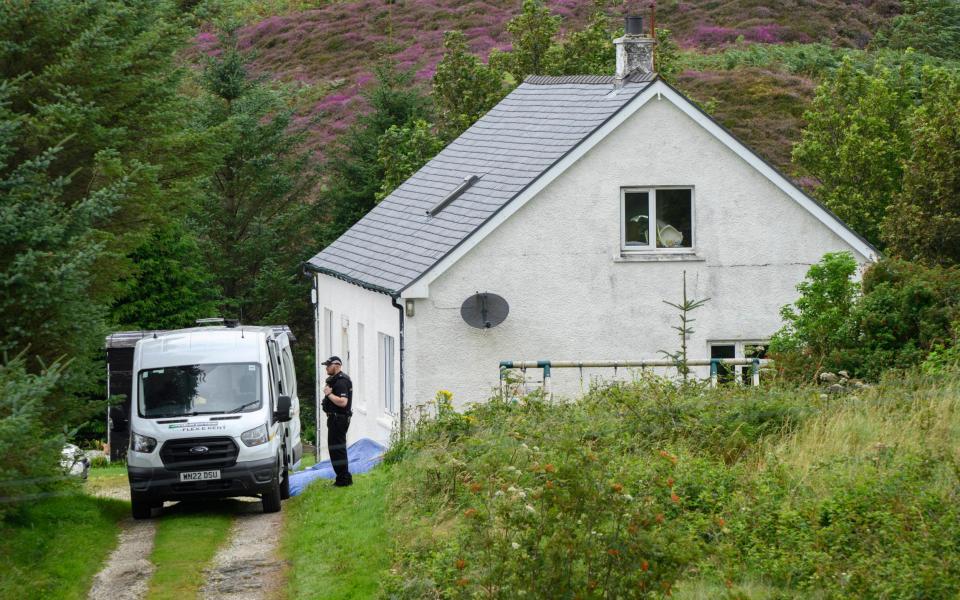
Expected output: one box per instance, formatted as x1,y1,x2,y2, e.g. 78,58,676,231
227,0,899,168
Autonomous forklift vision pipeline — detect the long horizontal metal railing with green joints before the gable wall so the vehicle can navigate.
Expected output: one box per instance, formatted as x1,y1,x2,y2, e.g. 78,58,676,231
500,358,773,397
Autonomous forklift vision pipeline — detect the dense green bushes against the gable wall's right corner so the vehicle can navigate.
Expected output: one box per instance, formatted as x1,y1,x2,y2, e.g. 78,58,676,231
770,253,960,379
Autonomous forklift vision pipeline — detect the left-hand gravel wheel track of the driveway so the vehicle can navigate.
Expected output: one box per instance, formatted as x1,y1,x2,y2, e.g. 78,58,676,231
87,519,156,600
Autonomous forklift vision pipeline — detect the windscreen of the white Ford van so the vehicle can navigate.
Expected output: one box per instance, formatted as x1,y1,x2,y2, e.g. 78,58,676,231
138,363,261,418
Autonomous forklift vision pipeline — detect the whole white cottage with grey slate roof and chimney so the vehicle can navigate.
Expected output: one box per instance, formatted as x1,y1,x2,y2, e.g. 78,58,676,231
309,19,877,450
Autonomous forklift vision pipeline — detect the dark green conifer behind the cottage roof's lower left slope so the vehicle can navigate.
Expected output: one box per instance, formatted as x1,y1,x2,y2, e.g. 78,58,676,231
321,61,430,244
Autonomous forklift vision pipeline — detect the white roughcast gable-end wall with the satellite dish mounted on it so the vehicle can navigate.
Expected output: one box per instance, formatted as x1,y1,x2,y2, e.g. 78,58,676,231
405,99,867,406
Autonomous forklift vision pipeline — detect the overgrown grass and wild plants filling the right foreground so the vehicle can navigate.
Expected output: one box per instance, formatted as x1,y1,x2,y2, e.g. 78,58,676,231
381,376,960,598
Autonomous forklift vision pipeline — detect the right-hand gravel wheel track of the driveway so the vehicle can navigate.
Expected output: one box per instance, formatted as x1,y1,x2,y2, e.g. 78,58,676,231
202,500,285,600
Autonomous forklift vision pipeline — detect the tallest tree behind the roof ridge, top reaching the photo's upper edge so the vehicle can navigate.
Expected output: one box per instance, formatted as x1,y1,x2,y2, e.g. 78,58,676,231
490,0,561,84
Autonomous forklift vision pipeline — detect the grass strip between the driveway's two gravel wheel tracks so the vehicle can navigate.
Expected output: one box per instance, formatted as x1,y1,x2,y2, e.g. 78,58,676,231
147,502,233,600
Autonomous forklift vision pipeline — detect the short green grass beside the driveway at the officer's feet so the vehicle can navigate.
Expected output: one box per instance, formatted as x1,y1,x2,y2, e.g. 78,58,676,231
281,467,391,600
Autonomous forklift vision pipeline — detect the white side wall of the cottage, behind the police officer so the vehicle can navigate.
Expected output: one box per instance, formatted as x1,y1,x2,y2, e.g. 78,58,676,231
316,273,400,456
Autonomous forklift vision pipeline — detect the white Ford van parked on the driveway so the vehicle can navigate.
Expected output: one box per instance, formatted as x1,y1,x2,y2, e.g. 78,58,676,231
127,323,303,519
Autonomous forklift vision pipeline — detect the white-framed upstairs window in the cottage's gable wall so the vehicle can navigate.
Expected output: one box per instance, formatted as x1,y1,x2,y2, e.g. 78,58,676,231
620,188,693,252
